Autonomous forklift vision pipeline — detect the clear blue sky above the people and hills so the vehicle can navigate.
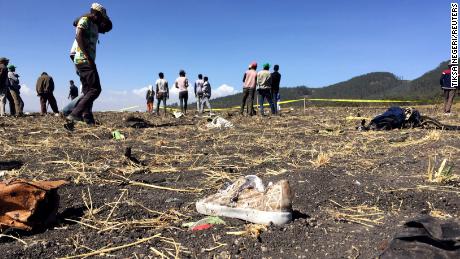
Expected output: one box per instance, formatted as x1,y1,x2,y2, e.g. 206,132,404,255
0,0,451,111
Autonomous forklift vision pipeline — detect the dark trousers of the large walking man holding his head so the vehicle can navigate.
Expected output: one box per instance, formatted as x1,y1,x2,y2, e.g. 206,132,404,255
71,64,102,120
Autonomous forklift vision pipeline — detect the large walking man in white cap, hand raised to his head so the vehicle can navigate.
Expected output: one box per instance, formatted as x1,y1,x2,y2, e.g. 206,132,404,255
66,3,112,125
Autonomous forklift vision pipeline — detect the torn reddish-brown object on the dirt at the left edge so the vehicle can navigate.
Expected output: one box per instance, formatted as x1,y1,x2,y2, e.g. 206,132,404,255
0,179,67,231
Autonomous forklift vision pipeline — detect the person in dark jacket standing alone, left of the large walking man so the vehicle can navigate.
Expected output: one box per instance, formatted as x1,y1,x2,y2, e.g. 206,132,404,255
36,72,59,115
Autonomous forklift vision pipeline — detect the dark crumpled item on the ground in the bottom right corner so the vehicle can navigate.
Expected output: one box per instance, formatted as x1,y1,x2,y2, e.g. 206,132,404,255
379,215,460,259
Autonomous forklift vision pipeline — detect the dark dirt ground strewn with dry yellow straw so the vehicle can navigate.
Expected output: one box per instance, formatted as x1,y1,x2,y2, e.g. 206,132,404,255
0,106,460,258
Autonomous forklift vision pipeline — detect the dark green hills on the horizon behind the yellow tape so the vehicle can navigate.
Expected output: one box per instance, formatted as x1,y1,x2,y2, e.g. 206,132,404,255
208,61,448,107
